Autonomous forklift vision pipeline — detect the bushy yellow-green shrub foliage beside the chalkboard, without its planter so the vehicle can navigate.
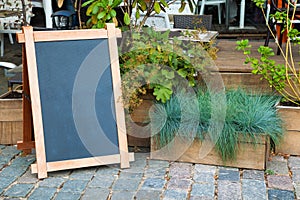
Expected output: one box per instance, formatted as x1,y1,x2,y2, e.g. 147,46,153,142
119,28,213,110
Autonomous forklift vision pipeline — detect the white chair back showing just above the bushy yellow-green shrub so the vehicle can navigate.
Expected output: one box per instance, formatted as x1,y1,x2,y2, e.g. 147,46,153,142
131,11,171,29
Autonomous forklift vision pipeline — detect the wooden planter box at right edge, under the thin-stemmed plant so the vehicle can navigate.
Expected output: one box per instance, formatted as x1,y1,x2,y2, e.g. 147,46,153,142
276,106,300,155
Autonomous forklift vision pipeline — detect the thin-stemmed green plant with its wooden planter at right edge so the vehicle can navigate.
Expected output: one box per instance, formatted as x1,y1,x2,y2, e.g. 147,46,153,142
237,0,300,155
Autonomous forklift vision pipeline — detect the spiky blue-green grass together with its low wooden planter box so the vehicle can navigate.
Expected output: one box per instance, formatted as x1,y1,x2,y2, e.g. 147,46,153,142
150,89,283,170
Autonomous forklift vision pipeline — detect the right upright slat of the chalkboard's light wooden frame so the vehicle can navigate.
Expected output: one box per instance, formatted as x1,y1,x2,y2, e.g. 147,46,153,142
106,23,130,168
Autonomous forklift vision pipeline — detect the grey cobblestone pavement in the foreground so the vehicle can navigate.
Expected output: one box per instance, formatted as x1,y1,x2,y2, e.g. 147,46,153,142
0,145,300,200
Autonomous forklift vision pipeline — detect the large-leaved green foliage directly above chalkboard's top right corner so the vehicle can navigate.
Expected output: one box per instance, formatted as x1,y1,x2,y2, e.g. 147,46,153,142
82,0,122,28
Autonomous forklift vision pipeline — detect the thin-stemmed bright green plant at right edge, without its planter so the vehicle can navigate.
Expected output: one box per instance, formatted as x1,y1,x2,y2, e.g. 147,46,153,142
237,0,300,105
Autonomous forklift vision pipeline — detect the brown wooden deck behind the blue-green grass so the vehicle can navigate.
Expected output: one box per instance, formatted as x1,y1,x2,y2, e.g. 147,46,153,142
211,39,300,92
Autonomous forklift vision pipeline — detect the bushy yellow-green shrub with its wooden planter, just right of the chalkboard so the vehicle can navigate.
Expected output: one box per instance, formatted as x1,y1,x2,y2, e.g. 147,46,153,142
119,28,218,146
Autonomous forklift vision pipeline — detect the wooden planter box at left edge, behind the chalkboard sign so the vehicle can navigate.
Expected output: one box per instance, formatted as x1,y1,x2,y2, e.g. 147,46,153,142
0,99,23,144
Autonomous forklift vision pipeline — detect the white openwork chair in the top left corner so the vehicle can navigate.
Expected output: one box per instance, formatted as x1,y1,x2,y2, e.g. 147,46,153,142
0,0,32,57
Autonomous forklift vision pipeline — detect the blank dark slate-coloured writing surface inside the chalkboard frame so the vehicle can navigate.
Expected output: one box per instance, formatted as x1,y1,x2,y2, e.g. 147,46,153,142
35,39,119,162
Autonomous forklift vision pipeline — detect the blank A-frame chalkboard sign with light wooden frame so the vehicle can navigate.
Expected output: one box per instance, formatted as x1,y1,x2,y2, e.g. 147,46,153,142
17,24,134,178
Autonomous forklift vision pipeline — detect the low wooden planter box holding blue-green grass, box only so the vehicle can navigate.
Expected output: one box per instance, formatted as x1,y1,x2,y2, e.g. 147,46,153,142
150,136,270,170
